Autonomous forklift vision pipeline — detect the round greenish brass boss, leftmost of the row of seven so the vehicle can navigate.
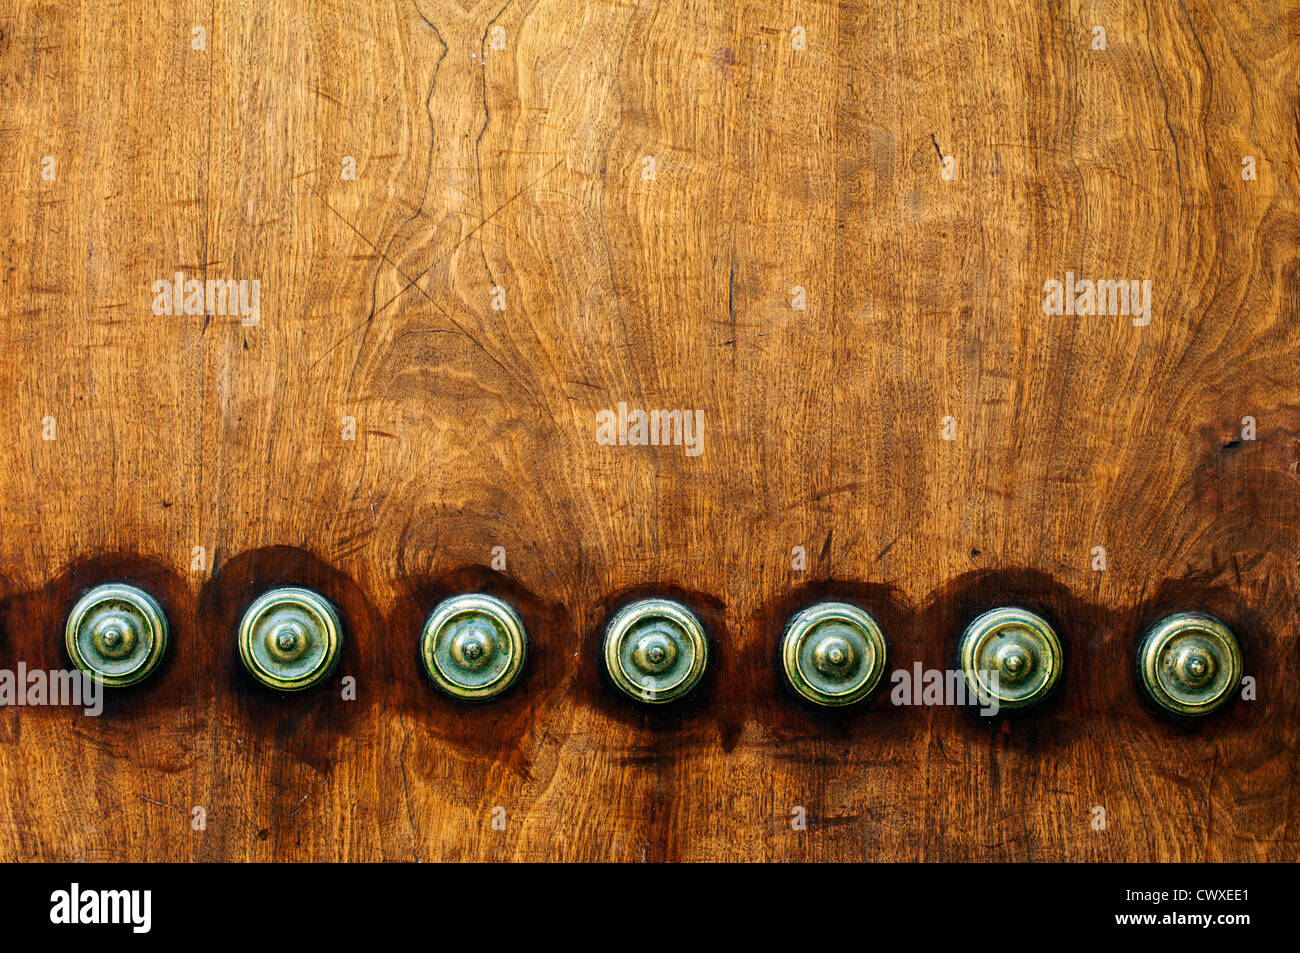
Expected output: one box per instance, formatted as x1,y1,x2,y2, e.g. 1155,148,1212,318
64,582,168,688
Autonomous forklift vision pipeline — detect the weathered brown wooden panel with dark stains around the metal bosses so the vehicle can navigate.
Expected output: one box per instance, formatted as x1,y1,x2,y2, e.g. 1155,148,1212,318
0,0,1300,861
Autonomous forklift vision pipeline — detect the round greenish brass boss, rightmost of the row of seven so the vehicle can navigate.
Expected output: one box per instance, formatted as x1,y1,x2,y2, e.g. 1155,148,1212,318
1138,612,1242,715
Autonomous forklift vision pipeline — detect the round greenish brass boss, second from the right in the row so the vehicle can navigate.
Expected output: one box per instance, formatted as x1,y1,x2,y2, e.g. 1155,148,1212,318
958,606,1065,709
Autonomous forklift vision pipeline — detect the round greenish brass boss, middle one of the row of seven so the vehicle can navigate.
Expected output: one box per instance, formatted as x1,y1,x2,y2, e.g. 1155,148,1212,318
605,599,709,705
